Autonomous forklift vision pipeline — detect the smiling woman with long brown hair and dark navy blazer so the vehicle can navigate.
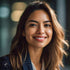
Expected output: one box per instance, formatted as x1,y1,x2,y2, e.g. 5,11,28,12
0,1,68,70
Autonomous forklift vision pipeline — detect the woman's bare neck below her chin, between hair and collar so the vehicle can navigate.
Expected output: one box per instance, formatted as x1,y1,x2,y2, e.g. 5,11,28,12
28,46,43,65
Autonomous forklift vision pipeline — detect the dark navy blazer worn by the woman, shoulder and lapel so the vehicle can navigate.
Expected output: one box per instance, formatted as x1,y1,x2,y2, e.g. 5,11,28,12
0,53,33,70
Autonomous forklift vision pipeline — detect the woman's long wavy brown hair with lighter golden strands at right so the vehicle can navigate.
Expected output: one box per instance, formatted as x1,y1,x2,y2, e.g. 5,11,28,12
10,1,68,70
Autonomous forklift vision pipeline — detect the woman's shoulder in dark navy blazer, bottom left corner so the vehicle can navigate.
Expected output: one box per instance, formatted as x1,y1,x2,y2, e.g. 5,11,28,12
0,55,12,70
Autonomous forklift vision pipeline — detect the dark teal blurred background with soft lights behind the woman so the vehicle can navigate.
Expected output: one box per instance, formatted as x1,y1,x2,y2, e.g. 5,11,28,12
0,0,70,70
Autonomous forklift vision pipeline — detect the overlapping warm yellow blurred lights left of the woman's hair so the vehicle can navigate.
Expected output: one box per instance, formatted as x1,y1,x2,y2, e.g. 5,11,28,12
11,2,27,22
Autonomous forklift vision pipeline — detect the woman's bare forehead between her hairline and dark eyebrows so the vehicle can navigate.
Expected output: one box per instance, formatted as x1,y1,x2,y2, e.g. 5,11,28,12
28,10,50,20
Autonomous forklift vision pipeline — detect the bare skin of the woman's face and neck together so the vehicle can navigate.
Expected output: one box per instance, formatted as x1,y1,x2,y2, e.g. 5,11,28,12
23,10,53,70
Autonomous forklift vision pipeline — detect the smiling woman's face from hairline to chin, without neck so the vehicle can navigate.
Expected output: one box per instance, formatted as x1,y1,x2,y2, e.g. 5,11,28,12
23,10,53,48
